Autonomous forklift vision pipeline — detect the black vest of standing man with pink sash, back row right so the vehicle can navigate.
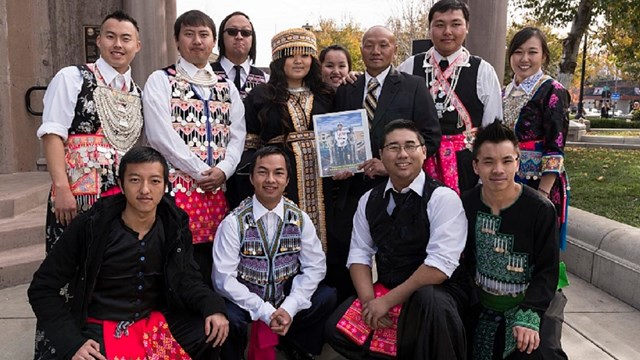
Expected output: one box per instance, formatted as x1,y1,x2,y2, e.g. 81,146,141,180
413,53,484,135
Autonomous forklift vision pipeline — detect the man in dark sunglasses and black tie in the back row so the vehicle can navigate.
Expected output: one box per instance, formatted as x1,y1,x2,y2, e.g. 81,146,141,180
211,11,269,99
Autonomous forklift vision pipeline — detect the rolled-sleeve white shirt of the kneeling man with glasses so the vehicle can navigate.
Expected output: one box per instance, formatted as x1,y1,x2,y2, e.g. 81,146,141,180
347,171,467,277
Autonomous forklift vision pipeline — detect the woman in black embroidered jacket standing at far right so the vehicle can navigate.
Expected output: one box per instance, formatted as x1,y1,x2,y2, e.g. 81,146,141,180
503,27,570,359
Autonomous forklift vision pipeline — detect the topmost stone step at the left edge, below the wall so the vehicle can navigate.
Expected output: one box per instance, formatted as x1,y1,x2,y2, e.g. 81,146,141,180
0,171,51,219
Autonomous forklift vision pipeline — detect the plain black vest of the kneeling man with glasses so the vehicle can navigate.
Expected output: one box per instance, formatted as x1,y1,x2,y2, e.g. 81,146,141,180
365,176,444,289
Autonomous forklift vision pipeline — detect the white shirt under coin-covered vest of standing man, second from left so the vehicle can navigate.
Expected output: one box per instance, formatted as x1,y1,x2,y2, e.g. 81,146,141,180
142,58,247,181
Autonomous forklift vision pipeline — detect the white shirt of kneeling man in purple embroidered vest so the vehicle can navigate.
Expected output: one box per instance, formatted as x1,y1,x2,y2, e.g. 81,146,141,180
211,195,327,325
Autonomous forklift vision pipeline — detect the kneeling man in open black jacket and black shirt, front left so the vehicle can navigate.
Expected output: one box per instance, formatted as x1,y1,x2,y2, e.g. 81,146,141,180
28,147,229,360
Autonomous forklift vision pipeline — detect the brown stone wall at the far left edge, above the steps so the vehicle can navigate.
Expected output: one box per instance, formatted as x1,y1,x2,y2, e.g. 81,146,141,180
0,0,50,173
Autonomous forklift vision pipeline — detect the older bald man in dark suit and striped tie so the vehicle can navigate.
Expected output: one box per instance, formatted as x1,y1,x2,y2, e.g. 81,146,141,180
327,26,440,300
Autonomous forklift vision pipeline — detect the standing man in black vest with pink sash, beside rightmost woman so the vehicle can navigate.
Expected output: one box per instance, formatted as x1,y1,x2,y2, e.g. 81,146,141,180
398,0,502,194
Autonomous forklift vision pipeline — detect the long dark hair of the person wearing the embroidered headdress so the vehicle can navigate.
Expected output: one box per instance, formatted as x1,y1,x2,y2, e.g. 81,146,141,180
258,56,333,138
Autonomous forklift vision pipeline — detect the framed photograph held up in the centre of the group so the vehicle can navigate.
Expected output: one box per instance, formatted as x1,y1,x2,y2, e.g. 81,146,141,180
313,109,371,177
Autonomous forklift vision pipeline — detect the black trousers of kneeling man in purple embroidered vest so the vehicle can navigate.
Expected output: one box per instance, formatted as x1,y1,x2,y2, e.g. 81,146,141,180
221,284,336,360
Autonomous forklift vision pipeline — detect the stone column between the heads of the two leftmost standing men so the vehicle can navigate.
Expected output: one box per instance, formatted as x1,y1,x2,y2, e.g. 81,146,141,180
123,0,176,87
